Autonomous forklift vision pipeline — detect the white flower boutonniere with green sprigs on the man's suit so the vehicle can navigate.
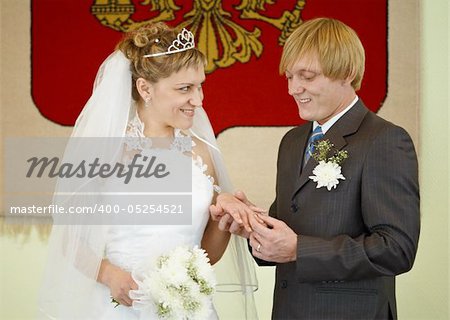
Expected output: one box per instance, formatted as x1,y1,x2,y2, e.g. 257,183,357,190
309,140,348,191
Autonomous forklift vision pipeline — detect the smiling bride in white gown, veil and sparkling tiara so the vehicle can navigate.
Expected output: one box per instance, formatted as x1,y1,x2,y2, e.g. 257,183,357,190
39,23,256,319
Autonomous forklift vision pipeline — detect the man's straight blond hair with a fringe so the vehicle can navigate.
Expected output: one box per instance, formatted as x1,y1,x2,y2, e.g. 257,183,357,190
279,18,365,90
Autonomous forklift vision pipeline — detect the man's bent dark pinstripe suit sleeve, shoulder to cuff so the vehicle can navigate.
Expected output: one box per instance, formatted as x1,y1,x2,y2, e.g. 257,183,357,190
296,126,420,282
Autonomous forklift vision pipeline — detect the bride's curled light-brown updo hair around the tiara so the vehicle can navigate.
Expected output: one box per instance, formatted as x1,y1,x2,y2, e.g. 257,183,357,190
116,22,206,101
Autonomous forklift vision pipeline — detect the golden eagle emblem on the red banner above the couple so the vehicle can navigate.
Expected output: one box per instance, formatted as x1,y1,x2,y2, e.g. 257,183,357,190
91,0,306,73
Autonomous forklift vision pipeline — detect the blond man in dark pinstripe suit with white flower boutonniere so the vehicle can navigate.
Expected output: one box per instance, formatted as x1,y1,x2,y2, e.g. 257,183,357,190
211,18,420,319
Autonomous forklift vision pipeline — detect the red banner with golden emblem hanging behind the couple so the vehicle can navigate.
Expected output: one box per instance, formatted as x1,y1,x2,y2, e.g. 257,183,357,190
31,0,388,133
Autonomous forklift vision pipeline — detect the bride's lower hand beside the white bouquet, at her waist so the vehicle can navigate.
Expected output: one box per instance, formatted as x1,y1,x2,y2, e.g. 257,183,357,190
98,260,138,307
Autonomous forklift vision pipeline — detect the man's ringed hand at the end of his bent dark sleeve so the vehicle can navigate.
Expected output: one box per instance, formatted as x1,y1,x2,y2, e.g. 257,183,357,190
250,214,297,263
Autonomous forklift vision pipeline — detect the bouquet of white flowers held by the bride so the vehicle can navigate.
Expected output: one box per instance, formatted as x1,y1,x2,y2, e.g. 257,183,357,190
130,246,216,319
